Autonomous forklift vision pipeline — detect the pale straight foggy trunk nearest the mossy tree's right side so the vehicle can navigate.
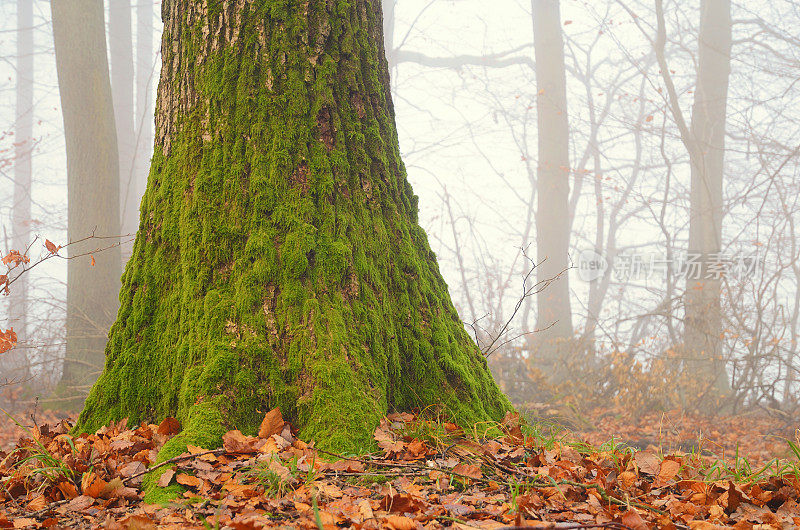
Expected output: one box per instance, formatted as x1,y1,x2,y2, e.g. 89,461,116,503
532,0,572,380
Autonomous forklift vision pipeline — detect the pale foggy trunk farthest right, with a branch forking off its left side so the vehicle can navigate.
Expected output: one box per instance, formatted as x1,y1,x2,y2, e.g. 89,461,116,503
684,0,731,399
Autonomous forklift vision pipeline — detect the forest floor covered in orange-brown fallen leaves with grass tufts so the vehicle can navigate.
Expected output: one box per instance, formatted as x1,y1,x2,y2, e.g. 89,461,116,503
0,406,800,530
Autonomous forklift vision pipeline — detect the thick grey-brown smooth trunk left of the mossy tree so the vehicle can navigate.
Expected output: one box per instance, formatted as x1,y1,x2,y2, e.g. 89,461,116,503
50,0,120,405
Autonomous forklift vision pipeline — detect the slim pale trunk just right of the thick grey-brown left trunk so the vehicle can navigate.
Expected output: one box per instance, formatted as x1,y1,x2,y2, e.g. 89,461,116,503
108,0,138,259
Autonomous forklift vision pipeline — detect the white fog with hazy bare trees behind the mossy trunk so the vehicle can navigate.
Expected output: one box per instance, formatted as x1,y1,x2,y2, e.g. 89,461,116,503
0,0,800,424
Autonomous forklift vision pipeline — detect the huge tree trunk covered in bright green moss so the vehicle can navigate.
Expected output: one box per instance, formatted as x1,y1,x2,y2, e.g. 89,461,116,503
79,0,508,450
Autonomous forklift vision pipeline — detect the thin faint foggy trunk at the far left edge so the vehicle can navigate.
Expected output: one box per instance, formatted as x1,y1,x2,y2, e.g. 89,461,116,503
2,0,34,381
